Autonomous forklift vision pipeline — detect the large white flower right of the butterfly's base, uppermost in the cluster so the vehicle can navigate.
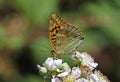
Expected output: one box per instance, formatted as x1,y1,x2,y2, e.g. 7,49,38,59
71,51,98,70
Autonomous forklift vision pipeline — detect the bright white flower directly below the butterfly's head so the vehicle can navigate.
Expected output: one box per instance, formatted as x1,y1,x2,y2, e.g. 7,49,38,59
43,58,62,71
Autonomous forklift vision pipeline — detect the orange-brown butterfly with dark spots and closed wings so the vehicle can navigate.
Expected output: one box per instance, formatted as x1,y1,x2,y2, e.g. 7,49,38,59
49,14,84,57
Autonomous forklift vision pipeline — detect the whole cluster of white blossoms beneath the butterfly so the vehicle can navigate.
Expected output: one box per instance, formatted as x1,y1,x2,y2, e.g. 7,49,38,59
37,51,110,82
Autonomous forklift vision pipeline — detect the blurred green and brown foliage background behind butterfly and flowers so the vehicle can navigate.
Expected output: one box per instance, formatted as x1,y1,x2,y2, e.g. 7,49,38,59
0,0,120,82
